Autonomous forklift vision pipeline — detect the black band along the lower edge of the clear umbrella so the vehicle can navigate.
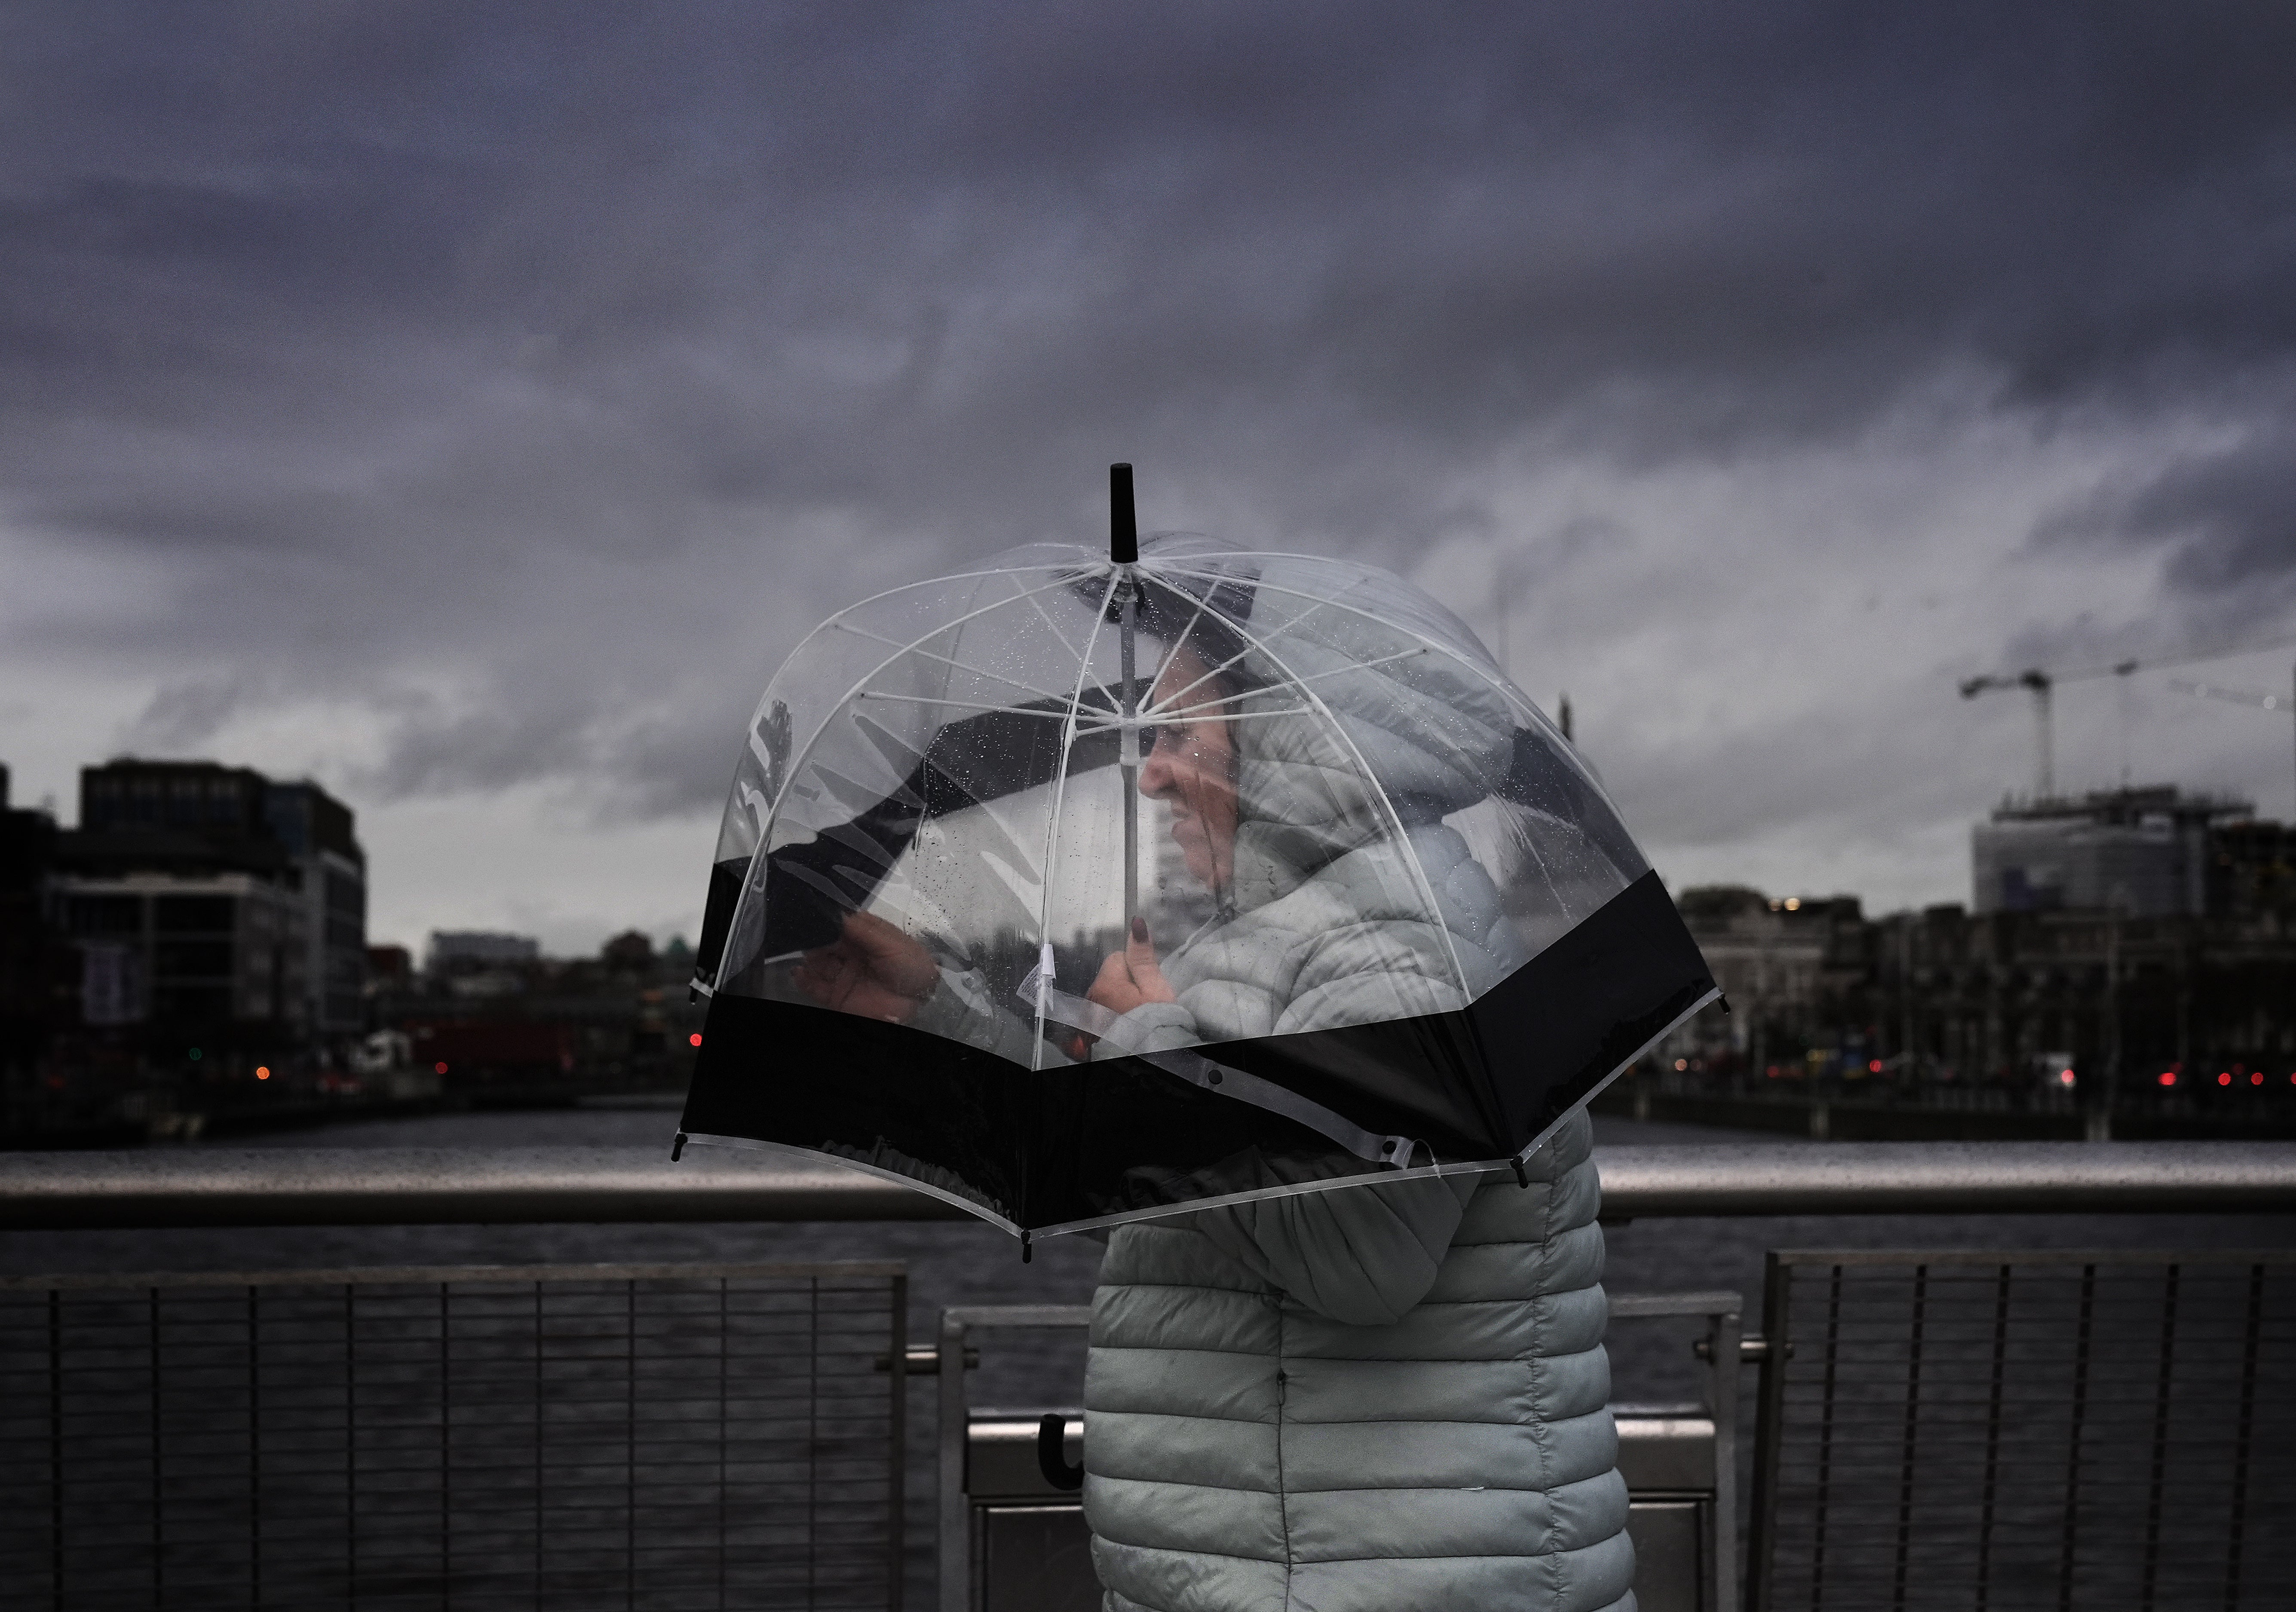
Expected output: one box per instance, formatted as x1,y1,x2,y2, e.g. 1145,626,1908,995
680,873,1713,1229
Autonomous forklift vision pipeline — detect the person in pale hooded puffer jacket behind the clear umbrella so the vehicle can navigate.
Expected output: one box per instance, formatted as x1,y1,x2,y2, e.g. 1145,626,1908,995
1084,634,1635,1612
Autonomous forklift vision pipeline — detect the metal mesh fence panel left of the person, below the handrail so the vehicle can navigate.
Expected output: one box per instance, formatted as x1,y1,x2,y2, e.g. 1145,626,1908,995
0,1263,907,1612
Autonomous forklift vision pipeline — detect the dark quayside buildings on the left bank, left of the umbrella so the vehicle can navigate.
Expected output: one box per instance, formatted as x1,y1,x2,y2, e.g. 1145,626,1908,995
0,758,700,1146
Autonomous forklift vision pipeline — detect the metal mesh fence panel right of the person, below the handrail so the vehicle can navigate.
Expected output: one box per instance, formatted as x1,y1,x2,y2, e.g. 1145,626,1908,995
1750,1251,2296,1612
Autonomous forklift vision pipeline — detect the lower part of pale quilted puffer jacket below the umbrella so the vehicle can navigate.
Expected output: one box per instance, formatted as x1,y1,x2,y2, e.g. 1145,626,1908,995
1084,1114,1635,1612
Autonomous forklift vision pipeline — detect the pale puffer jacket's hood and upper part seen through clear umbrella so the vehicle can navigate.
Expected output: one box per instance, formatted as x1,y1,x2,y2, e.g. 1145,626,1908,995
1079,579,1529,1056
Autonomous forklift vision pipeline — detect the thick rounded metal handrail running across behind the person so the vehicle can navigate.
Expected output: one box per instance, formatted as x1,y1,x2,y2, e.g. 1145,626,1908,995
0,1141,2296,1231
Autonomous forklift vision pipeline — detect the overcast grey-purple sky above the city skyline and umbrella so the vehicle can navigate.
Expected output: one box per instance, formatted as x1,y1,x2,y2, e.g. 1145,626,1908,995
0,0,2296,948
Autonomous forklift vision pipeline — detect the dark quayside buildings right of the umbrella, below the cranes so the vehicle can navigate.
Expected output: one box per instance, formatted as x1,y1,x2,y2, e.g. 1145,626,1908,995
1665,785,2296,1102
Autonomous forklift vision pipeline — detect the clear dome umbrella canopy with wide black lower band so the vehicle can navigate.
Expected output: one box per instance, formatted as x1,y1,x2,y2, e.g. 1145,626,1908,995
682,466,1717,1235
